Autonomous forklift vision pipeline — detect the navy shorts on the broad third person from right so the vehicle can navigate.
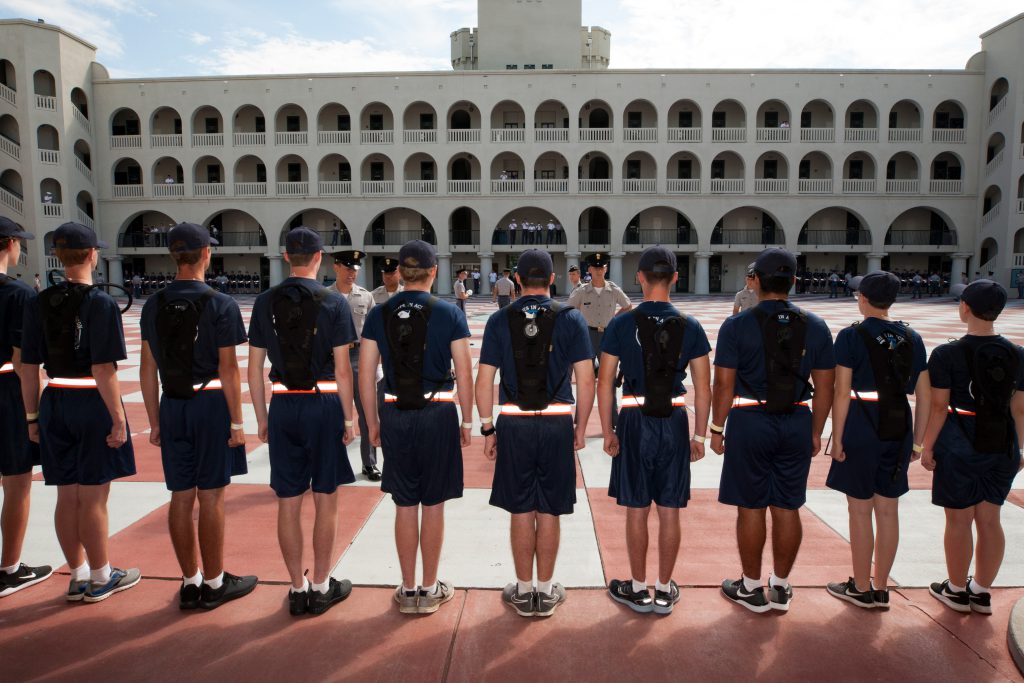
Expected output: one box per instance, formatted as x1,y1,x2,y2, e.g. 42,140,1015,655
718,405,812,510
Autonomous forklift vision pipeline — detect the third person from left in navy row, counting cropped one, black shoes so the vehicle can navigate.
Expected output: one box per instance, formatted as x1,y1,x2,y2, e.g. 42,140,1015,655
139,223,257,609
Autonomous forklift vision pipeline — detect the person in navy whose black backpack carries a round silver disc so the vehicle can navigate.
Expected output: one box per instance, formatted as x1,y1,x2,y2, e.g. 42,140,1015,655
476,249,594,616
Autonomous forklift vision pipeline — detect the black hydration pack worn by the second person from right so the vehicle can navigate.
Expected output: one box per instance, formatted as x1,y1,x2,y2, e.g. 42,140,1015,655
854,323,913,441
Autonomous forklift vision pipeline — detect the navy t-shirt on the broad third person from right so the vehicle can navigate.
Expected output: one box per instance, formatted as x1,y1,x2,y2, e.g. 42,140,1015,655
715,300,836,402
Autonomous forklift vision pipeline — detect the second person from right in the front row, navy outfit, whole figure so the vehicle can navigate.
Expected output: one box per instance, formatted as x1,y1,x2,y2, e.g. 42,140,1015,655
825,271,931,609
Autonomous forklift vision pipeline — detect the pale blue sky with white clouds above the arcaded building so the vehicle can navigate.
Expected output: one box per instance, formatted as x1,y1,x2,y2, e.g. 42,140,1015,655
0,0,1024,78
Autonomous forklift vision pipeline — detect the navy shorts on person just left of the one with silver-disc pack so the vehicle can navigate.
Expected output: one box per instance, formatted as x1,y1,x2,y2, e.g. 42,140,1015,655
381,401,462,507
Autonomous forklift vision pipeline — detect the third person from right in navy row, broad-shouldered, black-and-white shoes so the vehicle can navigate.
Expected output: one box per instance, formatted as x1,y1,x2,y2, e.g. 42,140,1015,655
709,248,836,612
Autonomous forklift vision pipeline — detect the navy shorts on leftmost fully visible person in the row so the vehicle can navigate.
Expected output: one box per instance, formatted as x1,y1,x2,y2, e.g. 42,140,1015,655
39,387,135,486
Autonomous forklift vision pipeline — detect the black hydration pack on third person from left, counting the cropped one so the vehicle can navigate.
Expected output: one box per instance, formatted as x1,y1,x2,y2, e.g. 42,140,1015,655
151,288,214,399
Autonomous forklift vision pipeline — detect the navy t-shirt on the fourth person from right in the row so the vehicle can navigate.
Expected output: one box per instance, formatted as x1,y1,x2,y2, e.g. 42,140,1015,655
601,301,711,396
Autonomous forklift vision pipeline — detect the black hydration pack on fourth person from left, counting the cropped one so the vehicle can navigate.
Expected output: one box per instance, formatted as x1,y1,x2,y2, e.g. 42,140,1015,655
270,283,327,391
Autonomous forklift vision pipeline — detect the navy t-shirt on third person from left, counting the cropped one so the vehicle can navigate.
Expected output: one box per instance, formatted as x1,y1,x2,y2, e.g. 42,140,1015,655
139,280,246,383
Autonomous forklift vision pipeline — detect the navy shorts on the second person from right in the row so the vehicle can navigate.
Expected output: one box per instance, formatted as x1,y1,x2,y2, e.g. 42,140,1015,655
825,400,913,501
